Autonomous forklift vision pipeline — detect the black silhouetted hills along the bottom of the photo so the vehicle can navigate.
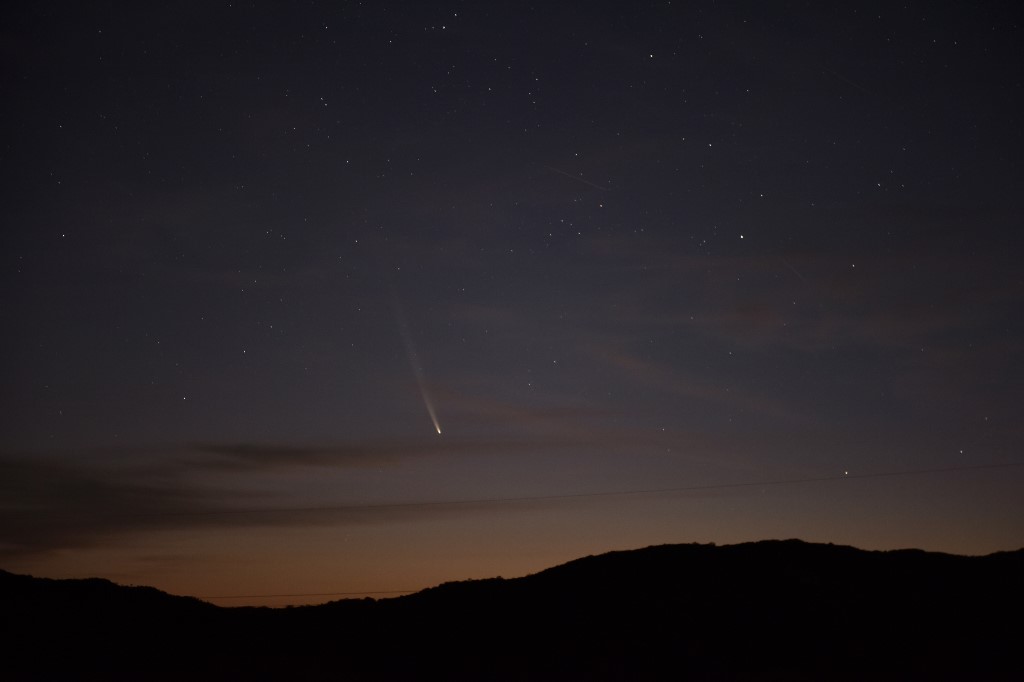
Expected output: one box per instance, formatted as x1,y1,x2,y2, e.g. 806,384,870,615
0,541,1024,680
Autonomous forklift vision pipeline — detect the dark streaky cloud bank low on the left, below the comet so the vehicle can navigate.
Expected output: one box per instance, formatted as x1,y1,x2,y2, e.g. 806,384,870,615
0,430,655,559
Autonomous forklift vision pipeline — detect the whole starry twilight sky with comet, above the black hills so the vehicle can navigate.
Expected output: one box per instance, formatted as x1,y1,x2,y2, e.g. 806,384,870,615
0,0,1024,605
